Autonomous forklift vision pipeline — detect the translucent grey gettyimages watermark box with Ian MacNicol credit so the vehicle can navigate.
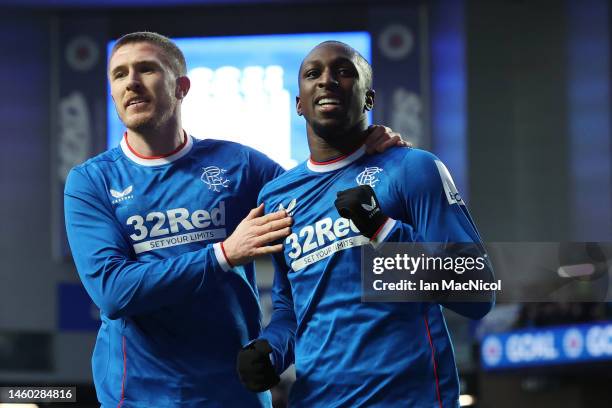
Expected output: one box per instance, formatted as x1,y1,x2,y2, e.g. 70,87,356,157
361,242,612,302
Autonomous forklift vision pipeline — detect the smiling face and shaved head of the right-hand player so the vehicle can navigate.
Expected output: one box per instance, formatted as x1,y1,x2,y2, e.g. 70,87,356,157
296,42,374,139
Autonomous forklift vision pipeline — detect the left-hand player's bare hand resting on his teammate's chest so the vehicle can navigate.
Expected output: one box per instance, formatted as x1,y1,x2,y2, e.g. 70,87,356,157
222,204,293,266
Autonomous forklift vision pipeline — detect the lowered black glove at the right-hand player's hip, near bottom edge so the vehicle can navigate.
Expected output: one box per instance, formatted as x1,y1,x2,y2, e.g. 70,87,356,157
236,339,280,392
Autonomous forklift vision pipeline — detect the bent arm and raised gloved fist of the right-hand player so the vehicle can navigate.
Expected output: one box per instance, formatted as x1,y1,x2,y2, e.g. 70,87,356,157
335,151,495,319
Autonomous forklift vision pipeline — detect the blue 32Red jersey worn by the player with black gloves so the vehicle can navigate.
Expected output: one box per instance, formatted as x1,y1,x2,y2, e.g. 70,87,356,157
260,147,492,408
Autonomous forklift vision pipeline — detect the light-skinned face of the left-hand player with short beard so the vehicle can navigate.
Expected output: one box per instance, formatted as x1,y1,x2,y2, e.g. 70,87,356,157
109,42,184,132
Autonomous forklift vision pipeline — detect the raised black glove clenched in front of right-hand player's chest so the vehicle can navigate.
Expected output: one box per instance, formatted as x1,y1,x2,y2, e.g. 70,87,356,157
334,185,388,238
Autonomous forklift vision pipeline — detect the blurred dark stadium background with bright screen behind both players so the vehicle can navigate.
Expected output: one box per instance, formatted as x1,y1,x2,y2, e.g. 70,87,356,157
0,0,612,408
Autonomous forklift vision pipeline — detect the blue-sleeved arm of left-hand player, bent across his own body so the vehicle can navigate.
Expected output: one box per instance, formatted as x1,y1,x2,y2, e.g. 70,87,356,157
64,169,290,319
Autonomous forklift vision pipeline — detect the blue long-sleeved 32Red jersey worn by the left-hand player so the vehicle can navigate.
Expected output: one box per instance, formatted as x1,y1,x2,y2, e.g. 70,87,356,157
64,136,283,407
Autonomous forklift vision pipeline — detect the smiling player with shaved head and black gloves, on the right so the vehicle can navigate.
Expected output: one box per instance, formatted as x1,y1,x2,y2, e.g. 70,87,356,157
238,41,493,408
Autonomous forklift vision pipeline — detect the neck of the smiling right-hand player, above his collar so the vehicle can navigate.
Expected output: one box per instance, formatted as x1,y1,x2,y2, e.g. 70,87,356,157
307,122,367,162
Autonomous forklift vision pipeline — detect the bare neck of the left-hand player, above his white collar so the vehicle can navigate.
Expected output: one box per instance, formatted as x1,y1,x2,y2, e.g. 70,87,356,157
127,118,185,157
